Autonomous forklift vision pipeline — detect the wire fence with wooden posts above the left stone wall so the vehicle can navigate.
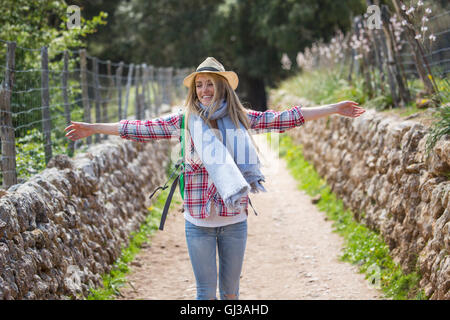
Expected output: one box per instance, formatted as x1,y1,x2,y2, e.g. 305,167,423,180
0,40,192,189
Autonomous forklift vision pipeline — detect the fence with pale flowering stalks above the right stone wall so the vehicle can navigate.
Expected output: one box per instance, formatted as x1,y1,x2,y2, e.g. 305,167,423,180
294,0,450,107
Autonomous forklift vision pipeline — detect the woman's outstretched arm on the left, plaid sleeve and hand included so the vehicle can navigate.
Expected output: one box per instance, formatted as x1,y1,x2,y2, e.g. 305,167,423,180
64,114,181,142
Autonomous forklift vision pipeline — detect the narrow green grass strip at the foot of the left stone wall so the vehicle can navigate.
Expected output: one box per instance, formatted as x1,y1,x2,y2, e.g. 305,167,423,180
87,188,180,300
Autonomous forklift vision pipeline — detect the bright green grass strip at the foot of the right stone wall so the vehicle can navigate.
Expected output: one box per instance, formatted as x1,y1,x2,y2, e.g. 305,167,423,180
272,134,427,300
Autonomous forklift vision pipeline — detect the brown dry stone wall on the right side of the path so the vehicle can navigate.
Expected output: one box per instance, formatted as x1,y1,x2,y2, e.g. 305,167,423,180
278,95,450,299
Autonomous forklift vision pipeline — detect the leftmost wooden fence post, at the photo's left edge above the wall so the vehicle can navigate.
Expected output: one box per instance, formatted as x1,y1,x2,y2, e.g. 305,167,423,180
0,42,17,189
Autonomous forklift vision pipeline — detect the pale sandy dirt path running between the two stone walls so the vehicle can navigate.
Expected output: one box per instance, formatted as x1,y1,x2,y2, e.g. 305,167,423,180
121,135,383,300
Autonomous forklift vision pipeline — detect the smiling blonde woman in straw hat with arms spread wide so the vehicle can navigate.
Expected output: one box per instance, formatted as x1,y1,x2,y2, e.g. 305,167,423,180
65,57,365,299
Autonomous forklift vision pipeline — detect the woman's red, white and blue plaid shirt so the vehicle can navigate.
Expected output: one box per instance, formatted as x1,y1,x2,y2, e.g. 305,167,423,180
119,106,305,219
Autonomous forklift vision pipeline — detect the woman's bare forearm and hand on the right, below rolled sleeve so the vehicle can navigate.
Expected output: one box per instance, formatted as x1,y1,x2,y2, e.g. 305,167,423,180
302,101,366,122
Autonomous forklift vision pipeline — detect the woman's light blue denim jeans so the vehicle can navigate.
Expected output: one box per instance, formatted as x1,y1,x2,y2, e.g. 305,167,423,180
185,221,247,300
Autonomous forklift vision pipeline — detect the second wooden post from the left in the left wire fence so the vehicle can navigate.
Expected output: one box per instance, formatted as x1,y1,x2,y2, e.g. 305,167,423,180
41,46,52,164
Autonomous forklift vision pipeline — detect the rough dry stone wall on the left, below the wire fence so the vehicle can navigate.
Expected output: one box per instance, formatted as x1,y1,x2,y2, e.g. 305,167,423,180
0,137,169,300
